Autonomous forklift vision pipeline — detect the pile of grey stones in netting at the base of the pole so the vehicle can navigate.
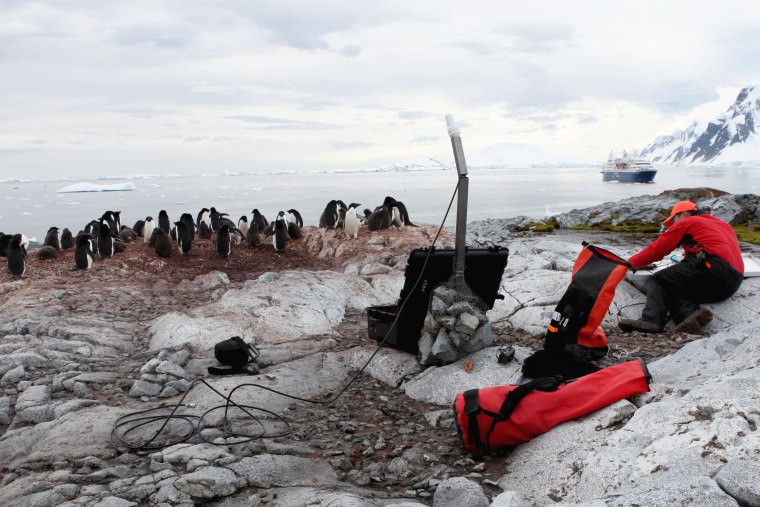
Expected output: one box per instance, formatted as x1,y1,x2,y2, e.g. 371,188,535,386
418,285,493,366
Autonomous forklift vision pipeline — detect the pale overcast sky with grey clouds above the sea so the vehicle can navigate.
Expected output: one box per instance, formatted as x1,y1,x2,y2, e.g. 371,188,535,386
0,0,760,177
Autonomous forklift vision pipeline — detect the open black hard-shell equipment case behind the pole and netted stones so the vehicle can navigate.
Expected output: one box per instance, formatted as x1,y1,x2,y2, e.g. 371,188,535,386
367,246,509,354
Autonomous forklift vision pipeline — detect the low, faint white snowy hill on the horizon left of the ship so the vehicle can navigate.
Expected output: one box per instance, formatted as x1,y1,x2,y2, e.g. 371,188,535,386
465,143,596,168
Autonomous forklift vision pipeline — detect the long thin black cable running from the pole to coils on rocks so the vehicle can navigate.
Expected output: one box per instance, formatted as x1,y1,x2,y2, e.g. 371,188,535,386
111,178,462,453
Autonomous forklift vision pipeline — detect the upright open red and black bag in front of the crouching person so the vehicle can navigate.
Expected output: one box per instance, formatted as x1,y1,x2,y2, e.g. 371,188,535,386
544,241,633,360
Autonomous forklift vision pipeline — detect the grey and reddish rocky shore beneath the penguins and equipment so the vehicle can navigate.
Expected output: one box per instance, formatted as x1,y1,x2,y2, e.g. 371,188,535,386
0,194,760,507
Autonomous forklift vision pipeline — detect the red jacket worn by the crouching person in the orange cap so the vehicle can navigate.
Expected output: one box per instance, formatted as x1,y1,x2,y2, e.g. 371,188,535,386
628,215,744,274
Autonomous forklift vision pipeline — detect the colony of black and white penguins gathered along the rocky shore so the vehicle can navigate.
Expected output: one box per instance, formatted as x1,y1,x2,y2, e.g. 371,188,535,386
0,197,416,279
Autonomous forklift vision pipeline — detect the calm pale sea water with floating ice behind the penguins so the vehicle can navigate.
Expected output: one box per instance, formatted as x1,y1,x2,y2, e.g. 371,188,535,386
0,166,760,242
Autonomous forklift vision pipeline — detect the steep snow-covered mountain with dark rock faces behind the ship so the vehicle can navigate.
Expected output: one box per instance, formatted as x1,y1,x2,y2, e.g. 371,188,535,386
639,86,760,165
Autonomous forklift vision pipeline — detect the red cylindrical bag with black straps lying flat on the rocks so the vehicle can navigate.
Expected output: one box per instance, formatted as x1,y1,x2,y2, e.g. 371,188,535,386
454,359,652,457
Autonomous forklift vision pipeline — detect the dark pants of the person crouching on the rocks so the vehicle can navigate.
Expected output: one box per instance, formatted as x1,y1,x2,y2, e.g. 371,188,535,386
641,255,744,329
